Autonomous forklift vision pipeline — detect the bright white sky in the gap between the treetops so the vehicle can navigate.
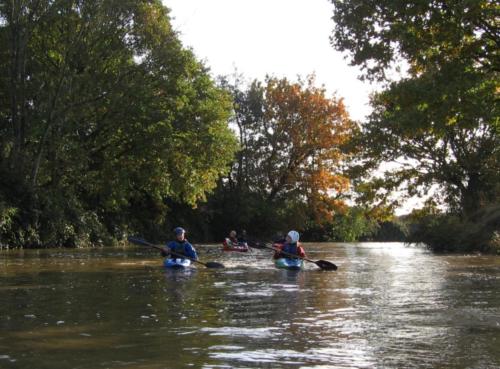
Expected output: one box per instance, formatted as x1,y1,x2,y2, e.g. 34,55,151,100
163,0,374,120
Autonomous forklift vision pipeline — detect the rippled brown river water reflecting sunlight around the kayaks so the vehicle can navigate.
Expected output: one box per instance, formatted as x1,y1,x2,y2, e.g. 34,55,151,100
0,243,500,369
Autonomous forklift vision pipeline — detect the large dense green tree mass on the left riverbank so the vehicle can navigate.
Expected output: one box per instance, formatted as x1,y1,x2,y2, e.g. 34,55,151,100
0,0,236,244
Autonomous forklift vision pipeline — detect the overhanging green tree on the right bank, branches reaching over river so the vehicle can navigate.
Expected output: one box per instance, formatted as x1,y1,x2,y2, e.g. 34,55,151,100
332,0,500,216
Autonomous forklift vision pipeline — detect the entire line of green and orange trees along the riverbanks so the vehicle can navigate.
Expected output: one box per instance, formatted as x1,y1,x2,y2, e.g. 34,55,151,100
0,0,500,251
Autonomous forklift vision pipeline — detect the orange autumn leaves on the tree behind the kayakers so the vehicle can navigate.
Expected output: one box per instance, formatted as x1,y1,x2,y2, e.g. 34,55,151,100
263,76,355,220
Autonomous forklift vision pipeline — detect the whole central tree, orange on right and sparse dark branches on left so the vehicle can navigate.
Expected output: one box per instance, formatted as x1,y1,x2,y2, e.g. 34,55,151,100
215,77,355,236
